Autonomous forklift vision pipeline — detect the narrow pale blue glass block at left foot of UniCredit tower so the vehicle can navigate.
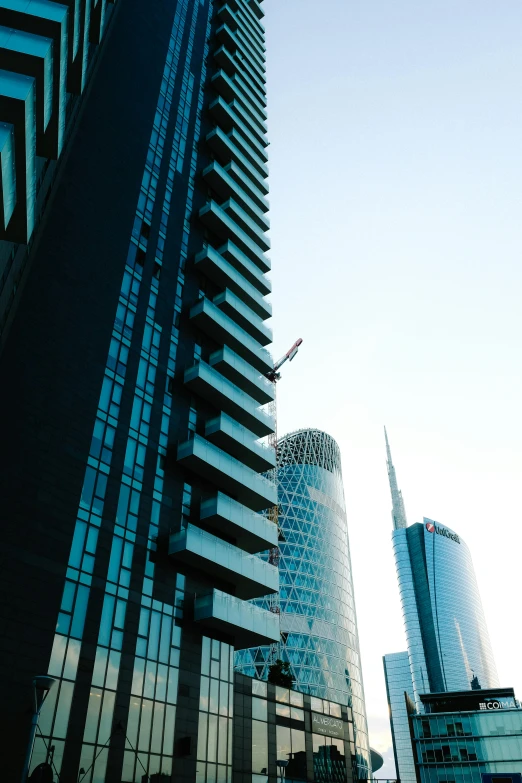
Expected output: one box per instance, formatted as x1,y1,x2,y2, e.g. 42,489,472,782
383,652,416,783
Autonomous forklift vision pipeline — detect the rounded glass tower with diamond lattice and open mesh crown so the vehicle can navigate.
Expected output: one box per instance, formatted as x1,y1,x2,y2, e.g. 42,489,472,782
236,429,370,778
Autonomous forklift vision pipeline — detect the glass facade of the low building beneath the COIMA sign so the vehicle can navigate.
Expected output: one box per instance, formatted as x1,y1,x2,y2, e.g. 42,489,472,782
412,709,522,783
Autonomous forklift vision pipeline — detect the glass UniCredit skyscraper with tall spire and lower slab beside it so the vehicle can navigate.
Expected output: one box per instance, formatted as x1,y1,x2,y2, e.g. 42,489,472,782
384,436,498,783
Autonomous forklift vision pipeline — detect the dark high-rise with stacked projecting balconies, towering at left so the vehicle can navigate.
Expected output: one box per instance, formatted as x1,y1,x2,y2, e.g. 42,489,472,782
0,0,279,783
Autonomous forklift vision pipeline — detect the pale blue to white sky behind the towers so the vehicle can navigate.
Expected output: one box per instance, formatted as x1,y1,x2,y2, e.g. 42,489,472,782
264,0,522,776
